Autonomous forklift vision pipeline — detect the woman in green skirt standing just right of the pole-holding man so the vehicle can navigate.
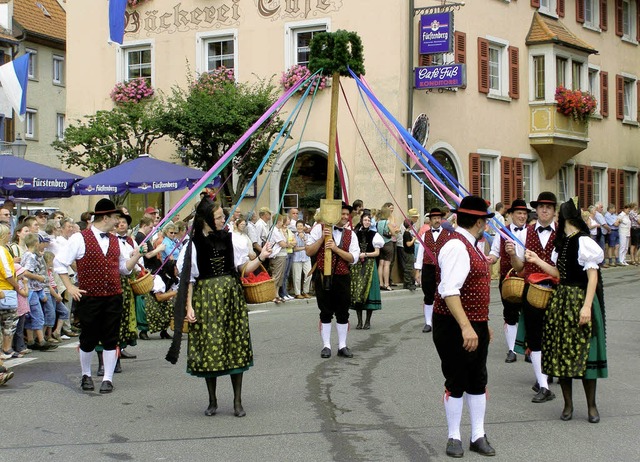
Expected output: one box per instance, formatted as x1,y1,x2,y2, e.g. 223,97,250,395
351,213,384,329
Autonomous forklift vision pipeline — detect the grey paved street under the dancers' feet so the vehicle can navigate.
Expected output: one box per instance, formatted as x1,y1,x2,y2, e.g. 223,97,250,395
0,267,640,462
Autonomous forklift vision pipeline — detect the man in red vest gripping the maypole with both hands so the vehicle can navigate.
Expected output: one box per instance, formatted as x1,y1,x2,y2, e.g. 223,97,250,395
306,202,360,358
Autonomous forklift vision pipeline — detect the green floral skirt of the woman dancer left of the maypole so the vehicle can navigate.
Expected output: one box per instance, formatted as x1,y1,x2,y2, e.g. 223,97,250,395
187,276,253,377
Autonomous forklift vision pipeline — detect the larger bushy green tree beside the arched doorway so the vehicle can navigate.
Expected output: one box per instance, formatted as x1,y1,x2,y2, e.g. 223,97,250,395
159,67,282,205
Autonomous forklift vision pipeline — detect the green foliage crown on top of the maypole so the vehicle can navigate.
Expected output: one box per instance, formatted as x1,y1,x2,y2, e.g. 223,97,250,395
309,30,365,77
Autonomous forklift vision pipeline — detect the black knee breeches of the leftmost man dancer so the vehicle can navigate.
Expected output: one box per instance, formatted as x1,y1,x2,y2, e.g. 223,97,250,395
76,294,122,353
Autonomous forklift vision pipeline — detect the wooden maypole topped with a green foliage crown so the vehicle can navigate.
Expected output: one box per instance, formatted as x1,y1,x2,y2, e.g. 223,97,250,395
309,30,364,290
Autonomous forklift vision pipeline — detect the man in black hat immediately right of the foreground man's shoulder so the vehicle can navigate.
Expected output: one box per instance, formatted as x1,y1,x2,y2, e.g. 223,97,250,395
489,199,531,363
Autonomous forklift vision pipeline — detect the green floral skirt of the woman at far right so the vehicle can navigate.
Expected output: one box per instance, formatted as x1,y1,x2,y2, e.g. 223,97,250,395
542,285,608,379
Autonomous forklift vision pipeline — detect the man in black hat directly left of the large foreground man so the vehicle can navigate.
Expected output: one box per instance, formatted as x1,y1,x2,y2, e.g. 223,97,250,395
414,208,451,332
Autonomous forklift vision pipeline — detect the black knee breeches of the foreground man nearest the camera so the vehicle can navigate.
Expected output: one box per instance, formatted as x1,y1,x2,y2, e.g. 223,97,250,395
433,313,489,398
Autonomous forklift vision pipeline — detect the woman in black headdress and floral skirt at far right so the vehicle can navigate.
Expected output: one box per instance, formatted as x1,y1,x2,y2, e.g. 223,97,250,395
526,200,608,423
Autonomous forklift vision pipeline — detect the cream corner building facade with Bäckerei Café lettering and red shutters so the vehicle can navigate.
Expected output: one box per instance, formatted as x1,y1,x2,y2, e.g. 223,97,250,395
66,0,640,219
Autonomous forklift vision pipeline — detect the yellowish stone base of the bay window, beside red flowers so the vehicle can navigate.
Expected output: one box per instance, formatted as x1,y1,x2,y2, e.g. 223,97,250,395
529,103,589,180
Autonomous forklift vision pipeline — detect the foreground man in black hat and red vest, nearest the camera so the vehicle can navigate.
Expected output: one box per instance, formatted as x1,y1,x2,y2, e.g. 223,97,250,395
433,196,495,457
